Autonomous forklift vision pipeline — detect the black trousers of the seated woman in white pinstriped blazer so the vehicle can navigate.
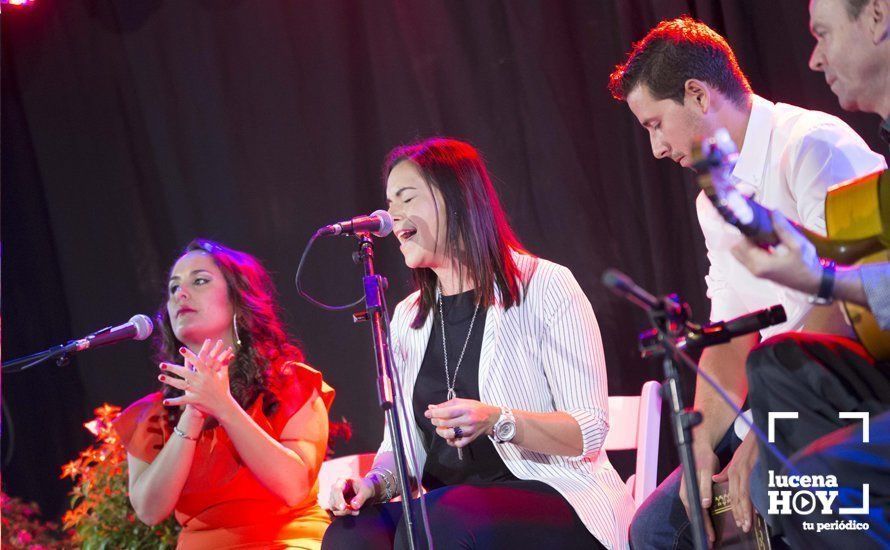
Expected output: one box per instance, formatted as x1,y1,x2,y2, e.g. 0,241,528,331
322,480,603,550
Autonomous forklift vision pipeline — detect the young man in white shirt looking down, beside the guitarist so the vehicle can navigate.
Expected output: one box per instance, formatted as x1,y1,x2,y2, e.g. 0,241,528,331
610,17,885,548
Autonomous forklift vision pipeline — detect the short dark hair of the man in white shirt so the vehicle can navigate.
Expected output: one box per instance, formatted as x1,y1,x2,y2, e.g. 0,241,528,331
609,16,751,105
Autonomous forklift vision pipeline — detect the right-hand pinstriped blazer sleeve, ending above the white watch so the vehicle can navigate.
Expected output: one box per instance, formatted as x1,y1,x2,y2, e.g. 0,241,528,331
542,265,609,461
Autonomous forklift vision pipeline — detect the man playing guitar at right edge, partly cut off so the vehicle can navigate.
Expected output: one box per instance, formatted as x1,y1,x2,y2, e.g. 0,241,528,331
733,0,890,548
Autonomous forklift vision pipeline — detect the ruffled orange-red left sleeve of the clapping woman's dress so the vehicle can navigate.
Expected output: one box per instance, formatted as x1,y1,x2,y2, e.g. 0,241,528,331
112,392,169,462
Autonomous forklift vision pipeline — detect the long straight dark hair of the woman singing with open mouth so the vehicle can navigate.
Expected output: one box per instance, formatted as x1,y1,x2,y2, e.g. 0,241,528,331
383,137,530,329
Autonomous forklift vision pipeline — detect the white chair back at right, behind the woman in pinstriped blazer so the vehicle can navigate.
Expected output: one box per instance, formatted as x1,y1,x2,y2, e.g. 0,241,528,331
604,380,661,508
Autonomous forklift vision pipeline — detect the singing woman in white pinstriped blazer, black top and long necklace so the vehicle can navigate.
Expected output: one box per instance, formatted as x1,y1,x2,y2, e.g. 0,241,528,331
323,138,633,549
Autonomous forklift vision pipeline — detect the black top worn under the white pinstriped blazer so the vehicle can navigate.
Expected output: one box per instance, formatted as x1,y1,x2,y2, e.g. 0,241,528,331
413,290,517,490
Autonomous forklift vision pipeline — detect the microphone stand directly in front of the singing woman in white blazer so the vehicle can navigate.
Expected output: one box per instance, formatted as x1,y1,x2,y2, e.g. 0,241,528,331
352,232,417,550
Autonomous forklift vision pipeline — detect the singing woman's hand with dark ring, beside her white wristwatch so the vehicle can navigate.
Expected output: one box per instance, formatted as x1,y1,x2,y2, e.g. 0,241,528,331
423,398,501,447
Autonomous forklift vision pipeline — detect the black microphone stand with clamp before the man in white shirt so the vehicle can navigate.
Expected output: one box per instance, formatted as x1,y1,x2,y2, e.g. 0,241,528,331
639,294,708,550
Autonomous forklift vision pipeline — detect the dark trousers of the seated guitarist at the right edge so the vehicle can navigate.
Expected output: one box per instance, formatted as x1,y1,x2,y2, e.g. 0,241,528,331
748,333,890,550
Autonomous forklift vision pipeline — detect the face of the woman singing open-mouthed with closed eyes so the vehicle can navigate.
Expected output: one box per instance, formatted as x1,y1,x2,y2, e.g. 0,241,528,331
386,160,447,269
